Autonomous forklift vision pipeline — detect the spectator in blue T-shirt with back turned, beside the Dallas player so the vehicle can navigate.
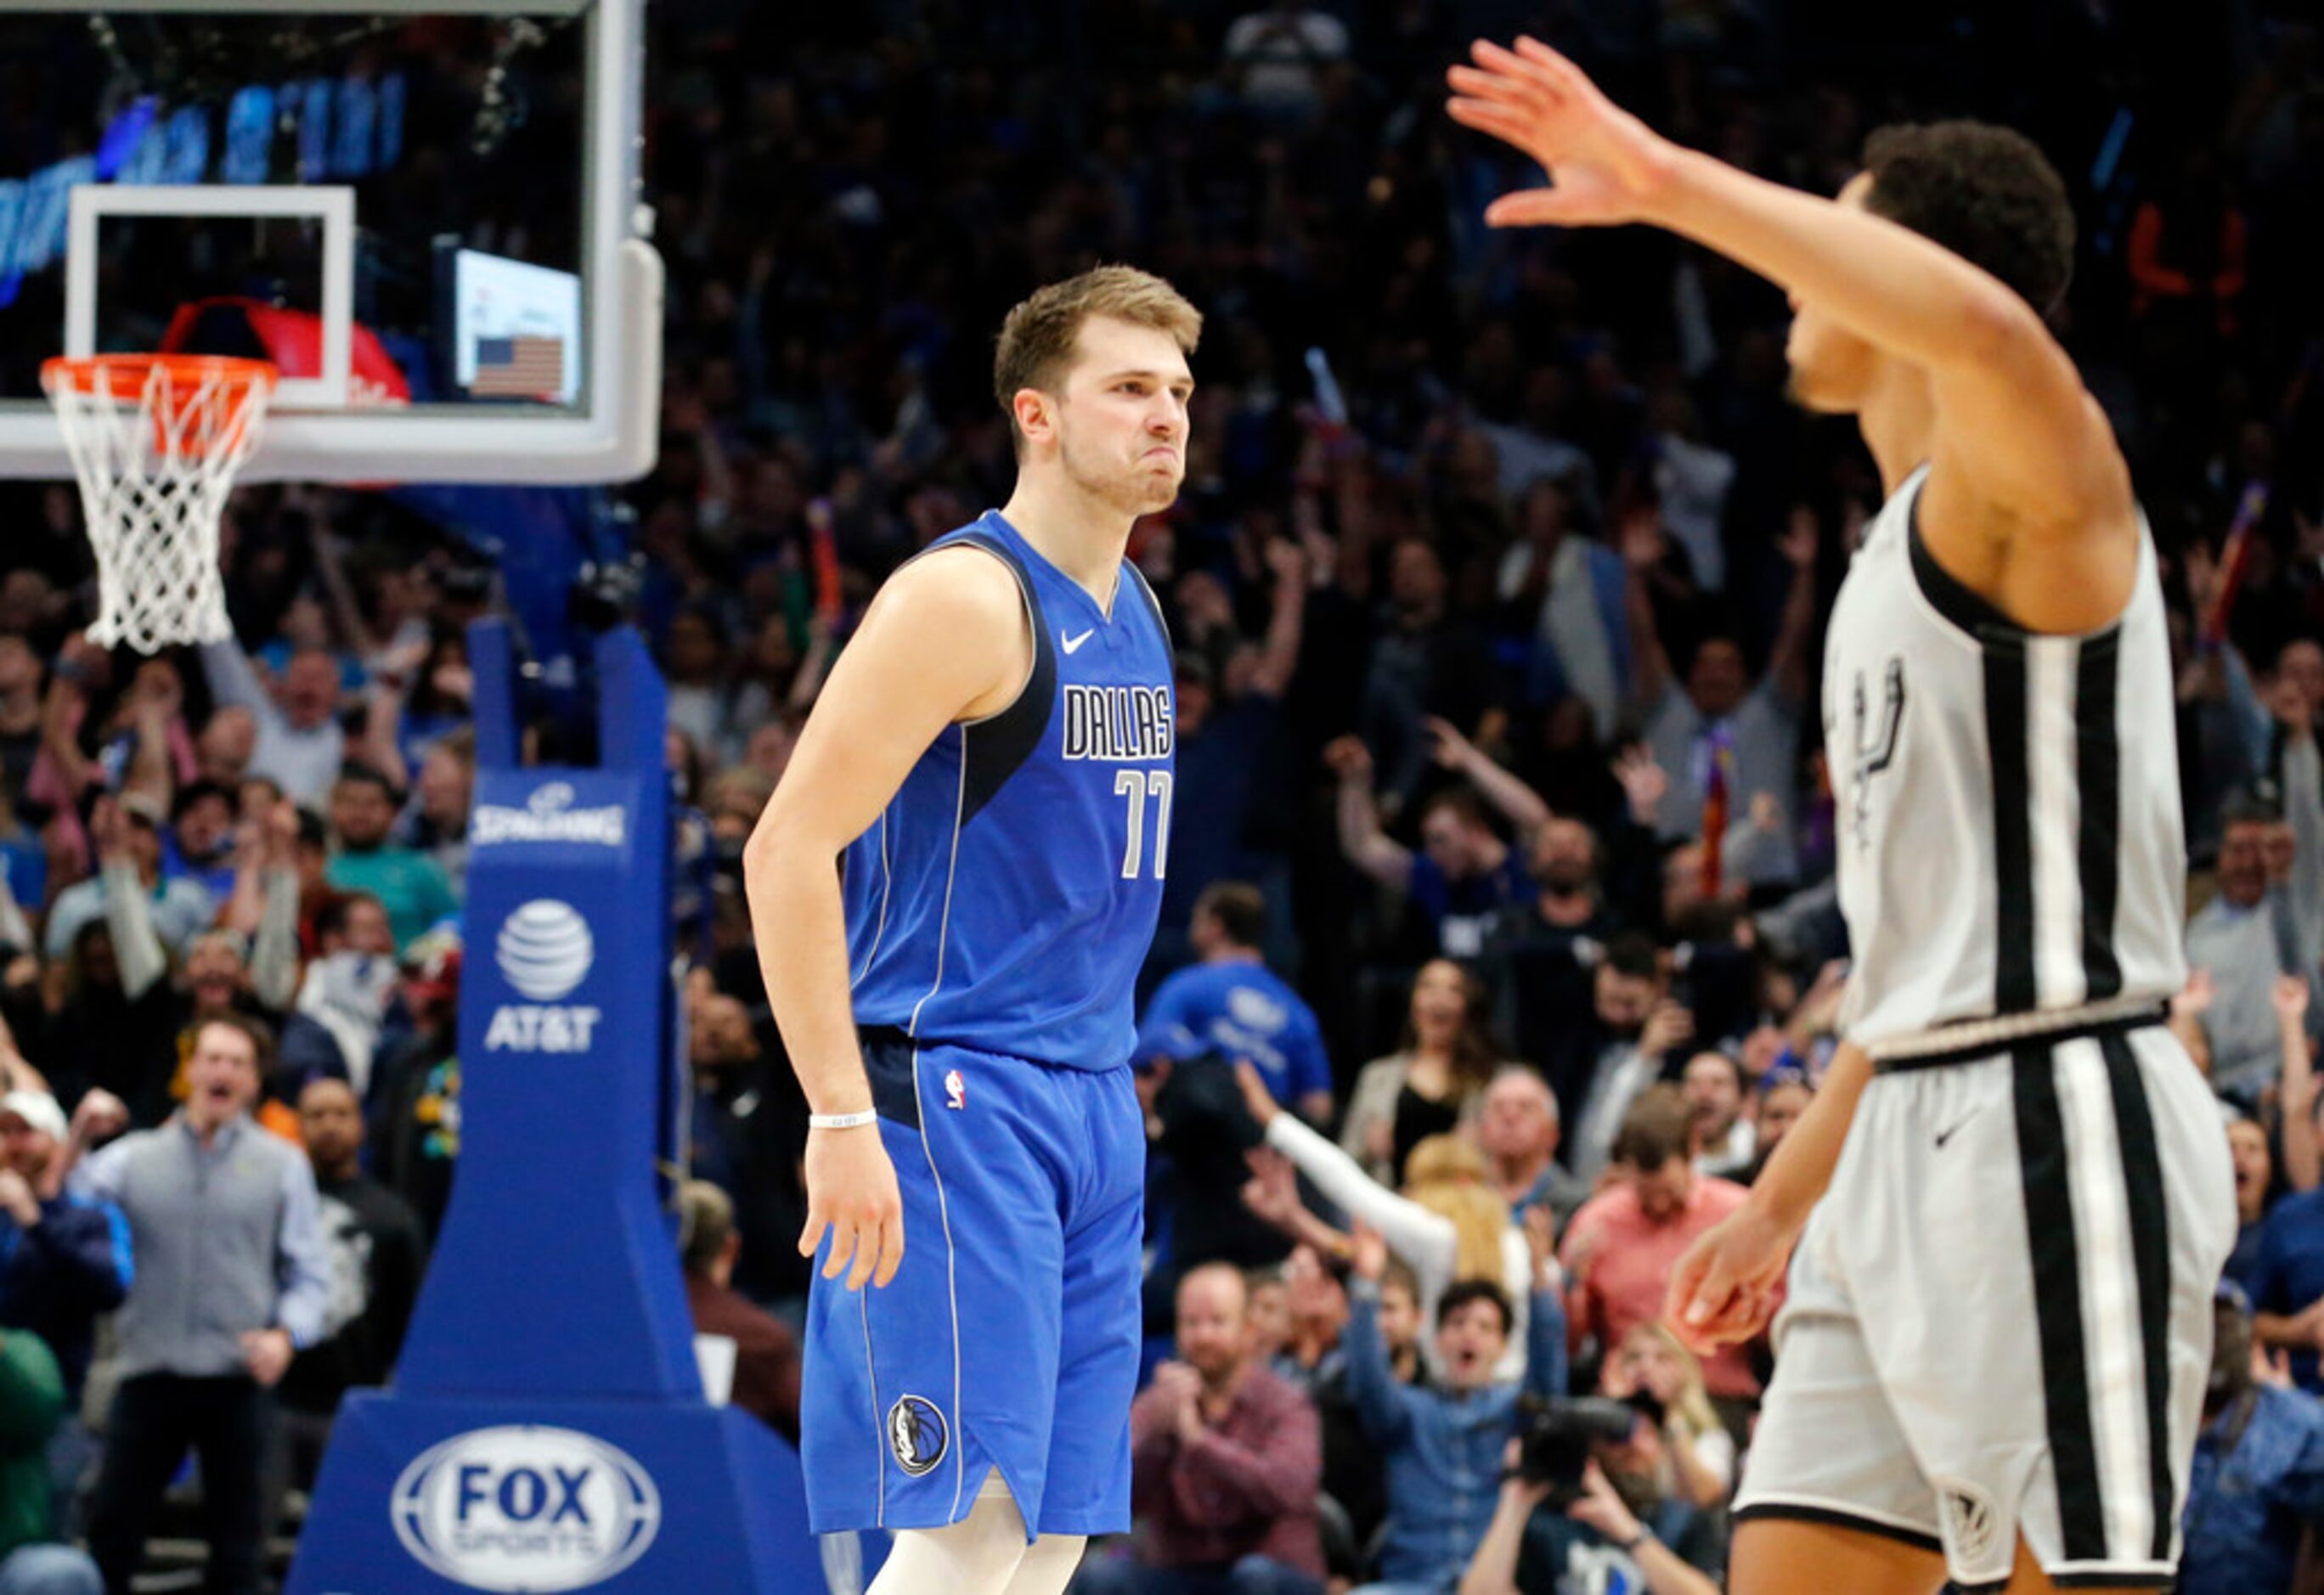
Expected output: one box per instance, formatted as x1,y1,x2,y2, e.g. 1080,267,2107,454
1137,882,1332,1125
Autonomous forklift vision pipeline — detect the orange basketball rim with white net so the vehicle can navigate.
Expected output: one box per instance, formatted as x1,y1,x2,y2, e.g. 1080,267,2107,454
40,353,279,653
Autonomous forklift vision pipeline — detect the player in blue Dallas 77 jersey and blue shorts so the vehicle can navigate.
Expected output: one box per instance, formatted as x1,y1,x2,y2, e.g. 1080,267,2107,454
744,268,1202,1595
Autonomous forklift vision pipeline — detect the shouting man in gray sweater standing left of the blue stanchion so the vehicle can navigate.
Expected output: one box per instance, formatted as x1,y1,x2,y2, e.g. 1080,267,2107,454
75,1016,330,1595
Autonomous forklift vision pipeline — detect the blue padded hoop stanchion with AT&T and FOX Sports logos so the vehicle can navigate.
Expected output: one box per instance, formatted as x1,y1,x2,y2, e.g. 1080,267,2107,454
288,623,823,1595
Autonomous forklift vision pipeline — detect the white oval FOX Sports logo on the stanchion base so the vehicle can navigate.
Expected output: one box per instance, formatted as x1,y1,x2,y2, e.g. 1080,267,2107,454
391,1423,663,1595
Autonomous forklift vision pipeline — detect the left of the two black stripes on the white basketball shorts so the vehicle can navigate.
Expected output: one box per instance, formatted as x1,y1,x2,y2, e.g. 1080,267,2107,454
2011,1044,2106,1563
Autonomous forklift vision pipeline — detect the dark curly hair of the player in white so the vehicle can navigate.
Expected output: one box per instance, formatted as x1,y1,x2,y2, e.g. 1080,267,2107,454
1864,121,2075,316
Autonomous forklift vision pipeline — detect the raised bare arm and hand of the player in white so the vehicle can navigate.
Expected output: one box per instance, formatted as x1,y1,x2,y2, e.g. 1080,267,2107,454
1450,40,2138,630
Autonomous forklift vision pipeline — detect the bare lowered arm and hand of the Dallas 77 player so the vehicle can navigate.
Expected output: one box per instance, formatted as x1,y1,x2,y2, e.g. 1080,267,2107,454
744,549,1032,1288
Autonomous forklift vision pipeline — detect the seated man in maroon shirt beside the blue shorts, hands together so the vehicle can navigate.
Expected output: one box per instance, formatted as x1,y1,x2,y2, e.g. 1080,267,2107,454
1074,1263,1325,1595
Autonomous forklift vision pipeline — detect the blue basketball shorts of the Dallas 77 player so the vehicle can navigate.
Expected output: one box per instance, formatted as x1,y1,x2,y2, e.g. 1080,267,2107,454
799,1030,1146,1535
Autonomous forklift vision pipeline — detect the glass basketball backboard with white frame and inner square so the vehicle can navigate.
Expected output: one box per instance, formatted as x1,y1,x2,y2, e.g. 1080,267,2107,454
0,0,660,482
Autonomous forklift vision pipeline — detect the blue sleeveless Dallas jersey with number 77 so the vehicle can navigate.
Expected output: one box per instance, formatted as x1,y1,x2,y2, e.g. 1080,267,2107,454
843,510,1176,1069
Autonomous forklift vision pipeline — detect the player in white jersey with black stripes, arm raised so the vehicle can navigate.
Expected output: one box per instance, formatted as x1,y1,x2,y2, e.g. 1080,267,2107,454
1450,40,2236,1595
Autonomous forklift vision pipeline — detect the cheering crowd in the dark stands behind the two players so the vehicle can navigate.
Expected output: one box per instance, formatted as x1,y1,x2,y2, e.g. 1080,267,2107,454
0,0,2324,1595
